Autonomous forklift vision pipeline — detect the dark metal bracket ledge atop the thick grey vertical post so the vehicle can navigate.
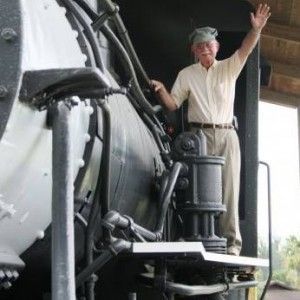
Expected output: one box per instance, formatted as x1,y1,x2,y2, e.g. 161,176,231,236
20,68,127,110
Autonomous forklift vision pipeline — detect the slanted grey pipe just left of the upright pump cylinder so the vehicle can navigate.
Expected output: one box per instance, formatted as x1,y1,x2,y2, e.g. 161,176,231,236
156,162,183,234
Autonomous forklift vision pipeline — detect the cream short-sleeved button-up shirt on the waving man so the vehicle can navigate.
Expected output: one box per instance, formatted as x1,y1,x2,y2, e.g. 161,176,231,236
171,51,245,124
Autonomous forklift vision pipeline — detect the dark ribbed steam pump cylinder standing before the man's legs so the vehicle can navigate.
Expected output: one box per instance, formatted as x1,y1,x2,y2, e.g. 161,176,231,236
175,131,226,253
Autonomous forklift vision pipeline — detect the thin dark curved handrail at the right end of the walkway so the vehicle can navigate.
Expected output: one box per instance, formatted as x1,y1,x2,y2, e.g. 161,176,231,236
259,161,273,300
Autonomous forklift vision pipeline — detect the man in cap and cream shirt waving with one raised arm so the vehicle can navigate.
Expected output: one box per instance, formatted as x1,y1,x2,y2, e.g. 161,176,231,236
152,4,271,255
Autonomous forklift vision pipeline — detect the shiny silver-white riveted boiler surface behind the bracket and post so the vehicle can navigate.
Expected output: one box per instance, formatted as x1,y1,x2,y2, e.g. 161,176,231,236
0,0,91,254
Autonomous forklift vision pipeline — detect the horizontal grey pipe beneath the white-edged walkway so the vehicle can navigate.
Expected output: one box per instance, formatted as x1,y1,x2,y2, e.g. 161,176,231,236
166,281,257,296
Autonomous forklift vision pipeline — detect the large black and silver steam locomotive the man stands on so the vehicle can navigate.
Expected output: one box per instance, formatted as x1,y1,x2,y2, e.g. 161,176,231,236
0,0,268,300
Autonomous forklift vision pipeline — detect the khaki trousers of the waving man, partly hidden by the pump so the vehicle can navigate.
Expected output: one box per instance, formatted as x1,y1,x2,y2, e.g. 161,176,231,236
191,127,242,255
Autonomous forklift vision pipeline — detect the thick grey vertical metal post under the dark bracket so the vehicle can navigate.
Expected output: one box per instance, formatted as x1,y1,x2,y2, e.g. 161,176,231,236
51,102,76,300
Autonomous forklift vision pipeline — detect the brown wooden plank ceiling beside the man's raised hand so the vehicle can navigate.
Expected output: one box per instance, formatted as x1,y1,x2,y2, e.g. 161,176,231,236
249,0,300,107
